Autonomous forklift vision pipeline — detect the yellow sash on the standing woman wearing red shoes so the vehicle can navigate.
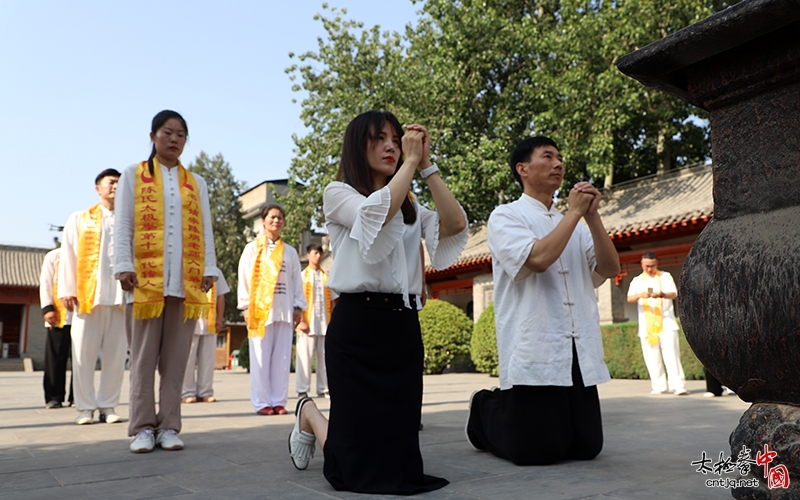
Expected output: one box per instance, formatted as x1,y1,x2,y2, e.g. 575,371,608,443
247,234,283,337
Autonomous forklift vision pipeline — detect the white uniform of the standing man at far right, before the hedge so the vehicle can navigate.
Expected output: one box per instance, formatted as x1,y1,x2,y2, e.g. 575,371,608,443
628,271,686,392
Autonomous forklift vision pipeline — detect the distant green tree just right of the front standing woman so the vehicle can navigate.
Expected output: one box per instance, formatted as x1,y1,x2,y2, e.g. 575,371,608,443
188,151,249,322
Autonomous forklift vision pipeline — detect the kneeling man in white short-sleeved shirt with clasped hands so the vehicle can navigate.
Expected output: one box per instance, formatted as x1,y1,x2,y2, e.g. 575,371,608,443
465,137,620,465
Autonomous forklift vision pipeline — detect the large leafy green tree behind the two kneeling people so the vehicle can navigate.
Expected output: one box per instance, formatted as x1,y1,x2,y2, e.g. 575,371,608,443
283,0,735,238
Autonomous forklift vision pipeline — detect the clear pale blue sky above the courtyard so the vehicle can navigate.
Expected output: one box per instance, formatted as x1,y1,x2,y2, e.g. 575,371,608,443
0,0,421,247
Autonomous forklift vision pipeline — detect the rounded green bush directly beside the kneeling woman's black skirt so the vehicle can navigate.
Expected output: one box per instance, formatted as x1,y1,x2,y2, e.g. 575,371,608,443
419,300,472,374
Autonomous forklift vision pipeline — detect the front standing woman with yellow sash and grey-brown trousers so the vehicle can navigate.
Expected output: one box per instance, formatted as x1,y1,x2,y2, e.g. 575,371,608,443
114,110,219,453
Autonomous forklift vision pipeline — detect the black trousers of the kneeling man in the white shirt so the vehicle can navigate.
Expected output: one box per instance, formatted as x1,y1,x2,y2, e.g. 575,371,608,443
467,344,603,465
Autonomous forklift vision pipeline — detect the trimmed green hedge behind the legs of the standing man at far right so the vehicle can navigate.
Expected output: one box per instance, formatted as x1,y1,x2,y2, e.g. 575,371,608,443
600,322,705,380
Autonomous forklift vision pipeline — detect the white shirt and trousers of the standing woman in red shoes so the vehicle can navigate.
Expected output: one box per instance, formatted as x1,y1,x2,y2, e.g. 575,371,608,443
237,240,308,411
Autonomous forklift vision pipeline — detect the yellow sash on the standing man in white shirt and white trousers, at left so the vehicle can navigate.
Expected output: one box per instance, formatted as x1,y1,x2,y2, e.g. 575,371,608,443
77,203,103,314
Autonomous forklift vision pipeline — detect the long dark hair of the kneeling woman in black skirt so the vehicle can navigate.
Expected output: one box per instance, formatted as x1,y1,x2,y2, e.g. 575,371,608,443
336,111,417,224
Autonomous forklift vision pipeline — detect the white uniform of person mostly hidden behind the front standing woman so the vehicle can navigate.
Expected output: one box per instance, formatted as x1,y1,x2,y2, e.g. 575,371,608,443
181,271,231,398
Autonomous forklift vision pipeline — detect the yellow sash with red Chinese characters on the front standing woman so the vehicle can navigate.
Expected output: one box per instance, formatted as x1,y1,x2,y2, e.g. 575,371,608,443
133,158,209,320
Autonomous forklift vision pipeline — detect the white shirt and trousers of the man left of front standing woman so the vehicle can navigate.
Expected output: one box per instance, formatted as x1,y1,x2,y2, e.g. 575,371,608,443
58,205,128,411
